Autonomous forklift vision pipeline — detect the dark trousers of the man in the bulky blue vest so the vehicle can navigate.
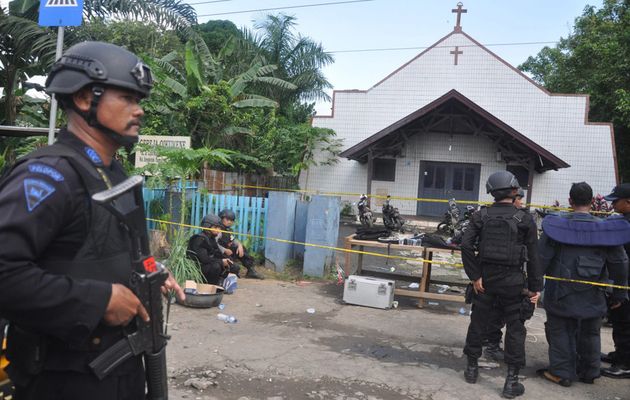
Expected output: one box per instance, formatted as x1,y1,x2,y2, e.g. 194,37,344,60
545,313,602,381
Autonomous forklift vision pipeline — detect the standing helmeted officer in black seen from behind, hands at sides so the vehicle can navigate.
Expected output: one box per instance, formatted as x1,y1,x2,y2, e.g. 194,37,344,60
461,171,543,399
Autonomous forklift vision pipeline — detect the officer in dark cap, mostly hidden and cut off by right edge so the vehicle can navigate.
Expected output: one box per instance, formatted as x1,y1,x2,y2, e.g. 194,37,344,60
602,183,630,379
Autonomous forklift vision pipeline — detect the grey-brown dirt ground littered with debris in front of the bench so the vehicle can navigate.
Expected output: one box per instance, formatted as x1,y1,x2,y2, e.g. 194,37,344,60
168,279,630,400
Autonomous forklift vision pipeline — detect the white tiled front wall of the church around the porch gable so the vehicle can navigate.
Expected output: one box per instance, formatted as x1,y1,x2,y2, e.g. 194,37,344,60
308,34,615,214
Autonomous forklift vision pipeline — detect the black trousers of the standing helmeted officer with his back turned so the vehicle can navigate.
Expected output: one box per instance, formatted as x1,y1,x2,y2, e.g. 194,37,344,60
464,292,527,368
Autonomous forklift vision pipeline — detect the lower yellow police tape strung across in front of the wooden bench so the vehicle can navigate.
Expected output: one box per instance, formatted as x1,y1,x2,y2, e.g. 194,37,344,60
147,218,630,290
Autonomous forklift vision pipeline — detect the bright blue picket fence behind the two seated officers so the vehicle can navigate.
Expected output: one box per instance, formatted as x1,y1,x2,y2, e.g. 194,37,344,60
144,188,267,251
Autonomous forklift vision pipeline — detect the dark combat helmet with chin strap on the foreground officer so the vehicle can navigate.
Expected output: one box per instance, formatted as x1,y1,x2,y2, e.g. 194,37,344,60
46,42,153,146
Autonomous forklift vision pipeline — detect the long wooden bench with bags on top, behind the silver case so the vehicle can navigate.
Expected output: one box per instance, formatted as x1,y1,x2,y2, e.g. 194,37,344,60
344,234,465,308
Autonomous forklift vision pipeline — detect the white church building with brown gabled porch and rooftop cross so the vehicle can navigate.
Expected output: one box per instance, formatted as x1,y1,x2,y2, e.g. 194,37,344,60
300,3,617,216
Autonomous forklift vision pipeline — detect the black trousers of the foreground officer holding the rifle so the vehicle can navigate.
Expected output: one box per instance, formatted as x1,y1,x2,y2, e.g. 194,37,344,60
14,368,145,400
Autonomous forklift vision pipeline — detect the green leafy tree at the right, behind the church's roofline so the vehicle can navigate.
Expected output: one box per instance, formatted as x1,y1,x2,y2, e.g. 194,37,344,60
519,0,630,181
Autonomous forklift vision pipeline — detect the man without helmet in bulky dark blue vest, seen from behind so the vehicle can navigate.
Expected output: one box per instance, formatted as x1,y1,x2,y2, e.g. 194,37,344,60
537,182,630,387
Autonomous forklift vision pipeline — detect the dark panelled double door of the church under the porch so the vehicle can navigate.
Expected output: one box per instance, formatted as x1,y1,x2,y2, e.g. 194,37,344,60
417,161,481,217
